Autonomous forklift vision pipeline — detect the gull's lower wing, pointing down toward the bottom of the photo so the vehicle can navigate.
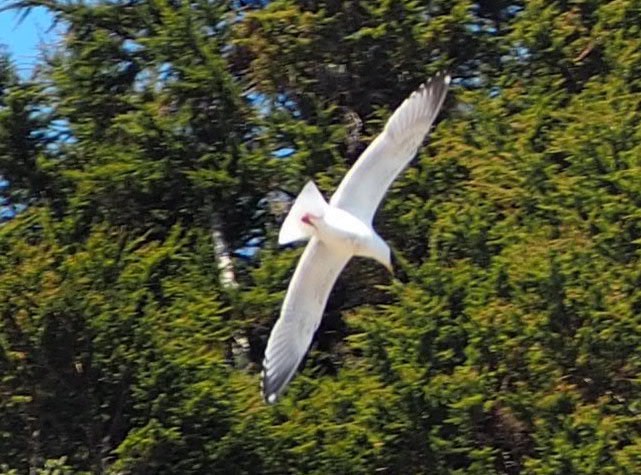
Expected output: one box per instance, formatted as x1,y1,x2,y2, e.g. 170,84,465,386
262,237,351,404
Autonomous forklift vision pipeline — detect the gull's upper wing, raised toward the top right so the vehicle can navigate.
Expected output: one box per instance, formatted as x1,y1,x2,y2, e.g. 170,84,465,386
330,74,450,222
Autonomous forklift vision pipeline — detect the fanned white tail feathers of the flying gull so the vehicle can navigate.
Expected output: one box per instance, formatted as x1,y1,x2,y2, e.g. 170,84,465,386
278,181,329,244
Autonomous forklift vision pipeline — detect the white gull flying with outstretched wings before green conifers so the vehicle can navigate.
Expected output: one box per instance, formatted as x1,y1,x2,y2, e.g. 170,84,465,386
262,74,450,404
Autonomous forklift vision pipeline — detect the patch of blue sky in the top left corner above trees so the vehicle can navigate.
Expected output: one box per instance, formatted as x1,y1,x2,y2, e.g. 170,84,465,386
0,8,56,76
